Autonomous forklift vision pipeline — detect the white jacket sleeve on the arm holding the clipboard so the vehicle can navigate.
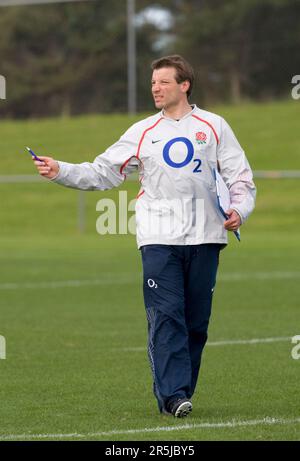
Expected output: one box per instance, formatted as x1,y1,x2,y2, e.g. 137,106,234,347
217,119,256,223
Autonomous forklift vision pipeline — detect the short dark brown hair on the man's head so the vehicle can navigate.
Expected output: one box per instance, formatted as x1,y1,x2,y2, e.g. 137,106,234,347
151,54,195,97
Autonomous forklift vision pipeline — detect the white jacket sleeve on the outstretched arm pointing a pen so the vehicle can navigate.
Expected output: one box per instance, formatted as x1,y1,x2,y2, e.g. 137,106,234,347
52,125,139,190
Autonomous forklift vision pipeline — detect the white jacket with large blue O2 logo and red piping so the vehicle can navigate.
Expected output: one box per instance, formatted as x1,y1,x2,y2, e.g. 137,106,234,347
53,105,256,248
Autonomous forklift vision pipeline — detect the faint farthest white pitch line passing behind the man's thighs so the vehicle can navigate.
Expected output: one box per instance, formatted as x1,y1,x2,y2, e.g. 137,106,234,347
0,271,300,290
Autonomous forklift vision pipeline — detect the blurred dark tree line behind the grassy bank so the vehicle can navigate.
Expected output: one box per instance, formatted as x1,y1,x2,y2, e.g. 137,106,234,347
0,0,300,118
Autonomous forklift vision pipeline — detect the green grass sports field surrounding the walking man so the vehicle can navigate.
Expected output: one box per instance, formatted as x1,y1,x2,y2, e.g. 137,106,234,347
0,101,300,441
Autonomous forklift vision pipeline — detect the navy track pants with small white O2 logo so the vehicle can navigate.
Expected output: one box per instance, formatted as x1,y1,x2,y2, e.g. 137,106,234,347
141,244,223,411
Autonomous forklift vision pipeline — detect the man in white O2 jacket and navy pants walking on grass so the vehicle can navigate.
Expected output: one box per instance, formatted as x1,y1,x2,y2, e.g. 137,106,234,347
35,55,256,417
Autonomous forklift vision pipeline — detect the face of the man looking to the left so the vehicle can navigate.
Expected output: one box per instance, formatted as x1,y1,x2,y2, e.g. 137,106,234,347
152,67,189,110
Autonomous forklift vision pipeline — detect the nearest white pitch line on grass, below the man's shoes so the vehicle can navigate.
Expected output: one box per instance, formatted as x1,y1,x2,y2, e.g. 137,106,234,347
0,416,300,440
